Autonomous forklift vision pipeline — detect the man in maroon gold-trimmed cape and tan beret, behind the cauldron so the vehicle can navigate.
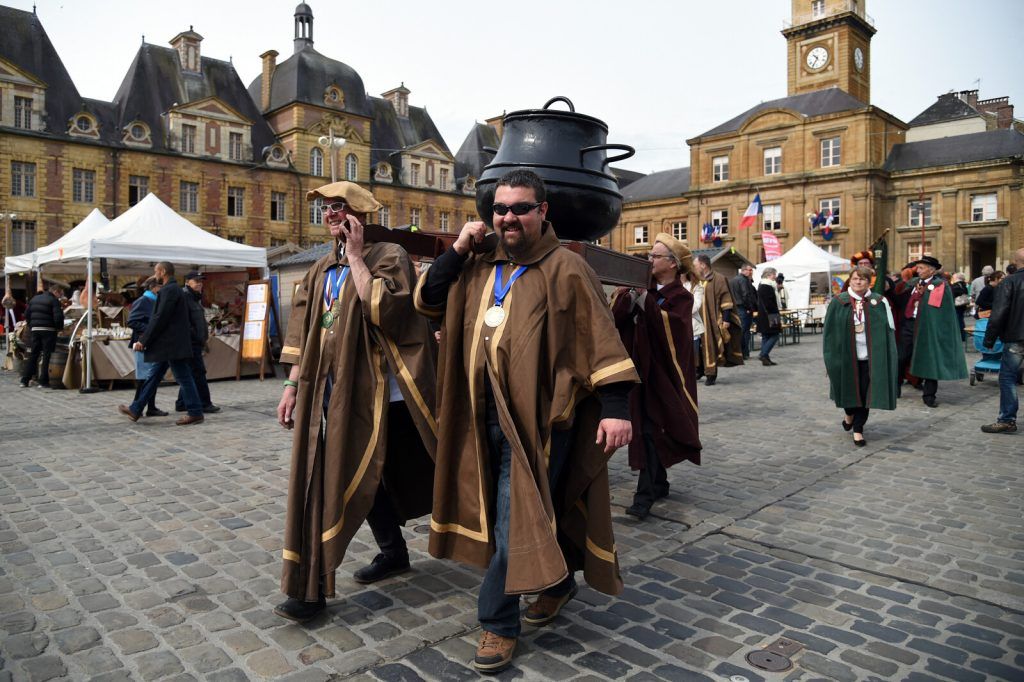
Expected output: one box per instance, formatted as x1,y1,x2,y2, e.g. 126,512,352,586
611,232,700,519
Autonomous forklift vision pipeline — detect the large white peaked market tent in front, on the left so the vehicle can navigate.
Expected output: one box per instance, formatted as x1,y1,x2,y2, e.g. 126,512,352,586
4,194,267,388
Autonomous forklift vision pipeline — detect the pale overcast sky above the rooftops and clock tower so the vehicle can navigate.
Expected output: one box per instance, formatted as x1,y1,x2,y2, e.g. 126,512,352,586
9,0,1024,173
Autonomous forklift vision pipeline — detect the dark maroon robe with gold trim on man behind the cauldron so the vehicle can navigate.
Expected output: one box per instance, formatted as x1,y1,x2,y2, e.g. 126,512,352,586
611,280,700,470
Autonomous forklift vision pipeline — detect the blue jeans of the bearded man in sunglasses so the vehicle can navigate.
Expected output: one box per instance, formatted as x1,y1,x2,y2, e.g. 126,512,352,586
476,424,575,637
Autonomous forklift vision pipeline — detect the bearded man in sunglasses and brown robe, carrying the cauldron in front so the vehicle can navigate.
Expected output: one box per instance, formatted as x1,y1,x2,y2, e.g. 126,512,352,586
416,170,637,673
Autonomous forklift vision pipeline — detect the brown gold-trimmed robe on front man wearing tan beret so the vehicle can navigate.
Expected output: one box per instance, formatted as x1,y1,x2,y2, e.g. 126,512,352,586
281,243,437,601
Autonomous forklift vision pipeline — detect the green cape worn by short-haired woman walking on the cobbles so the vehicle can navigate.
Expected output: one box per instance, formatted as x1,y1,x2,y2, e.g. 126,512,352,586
822,292,899,410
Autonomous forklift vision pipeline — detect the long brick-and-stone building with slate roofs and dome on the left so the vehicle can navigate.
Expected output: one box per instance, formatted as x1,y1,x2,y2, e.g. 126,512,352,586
0,3,475,266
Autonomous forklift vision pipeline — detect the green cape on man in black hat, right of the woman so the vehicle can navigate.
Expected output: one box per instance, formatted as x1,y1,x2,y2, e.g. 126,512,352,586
913,275,968,381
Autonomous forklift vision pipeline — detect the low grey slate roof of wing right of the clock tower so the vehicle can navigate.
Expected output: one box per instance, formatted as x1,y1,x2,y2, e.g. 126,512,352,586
884,130,1024,172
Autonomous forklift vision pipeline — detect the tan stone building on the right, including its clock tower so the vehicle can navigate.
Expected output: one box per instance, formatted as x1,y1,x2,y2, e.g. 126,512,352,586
609,0,1024,273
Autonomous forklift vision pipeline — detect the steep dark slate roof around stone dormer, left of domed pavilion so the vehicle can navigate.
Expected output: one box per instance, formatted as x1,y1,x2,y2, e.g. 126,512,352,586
114,44,274,156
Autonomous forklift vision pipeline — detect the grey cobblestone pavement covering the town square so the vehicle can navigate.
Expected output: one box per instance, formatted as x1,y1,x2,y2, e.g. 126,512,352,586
0,336,1024,681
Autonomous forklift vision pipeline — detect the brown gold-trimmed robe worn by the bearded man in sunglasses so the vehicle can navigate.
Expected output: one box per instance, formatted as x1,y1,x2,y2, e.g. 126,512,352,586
416,223,637,594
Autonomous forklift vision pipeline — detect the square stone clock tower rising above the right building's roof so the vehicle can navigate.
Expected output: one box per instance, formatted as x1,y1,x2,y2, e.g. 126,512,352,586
782,0,874,103
